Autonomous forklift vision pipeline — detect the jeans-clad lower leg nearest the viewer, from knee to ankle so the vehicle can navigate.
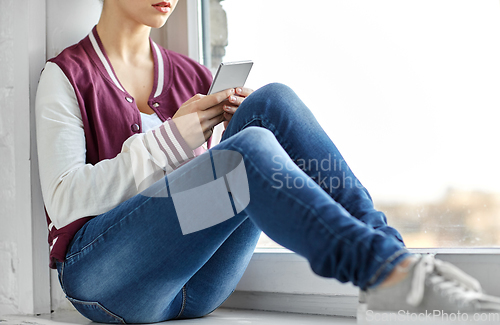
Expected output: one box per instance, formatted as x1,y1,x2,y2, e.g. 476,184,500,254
217,127,408,289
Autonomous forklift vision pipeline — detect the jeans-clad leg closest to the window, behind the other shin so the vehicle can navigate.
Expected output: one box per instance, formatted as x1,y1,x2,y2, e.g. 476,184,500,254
222,84,403,242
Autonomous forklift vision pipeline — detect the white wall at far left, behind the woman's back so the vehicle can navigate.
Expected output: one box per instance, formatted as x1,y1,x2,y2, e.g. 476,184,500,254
0,0,50,313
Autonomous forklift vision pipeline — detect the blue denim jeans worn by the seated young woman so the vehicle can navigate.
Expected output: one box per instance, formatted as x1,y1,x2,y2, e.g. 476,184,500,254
57,84,409,323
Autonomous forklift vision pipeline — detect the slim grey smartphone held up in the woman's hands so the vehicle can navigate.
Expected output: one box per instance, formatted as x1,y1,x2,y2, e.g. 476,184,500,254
208,61,253,95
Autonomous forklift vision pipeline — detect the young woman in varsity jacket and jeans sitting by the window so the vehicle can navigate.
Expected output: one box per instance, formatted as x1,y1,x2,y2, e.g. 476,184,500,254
36,0,500,323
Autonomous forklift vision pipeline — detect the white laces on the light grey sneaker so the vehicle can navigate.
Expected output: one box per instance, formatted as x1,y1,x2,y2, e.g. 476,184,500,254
406,255,484,306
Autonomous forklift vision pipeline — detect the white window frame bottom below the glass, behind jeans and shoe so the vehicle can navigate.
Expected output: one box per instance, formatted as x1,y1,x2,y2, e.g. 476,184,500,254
223,248,500,317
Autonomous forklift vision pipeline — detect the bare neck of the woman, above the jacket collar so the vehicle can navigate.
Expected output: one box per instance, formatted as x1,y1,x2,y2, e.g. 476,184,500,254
97,8,151,64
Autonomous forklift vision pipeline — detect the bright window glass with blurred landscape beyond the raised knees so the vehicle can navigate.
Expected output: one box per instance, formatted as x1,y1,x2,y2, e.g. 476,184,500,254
203,0,500,247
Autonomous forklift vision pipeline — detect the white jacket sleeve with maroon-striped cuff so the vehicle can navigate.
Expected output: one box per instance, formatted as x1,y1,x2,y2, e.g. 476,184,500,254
35,62,194,228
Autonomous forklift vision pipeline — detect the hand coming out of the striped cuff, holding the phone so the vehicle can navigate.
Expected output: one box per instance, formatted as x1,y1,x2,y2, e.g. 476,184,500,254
172,89,234,149
